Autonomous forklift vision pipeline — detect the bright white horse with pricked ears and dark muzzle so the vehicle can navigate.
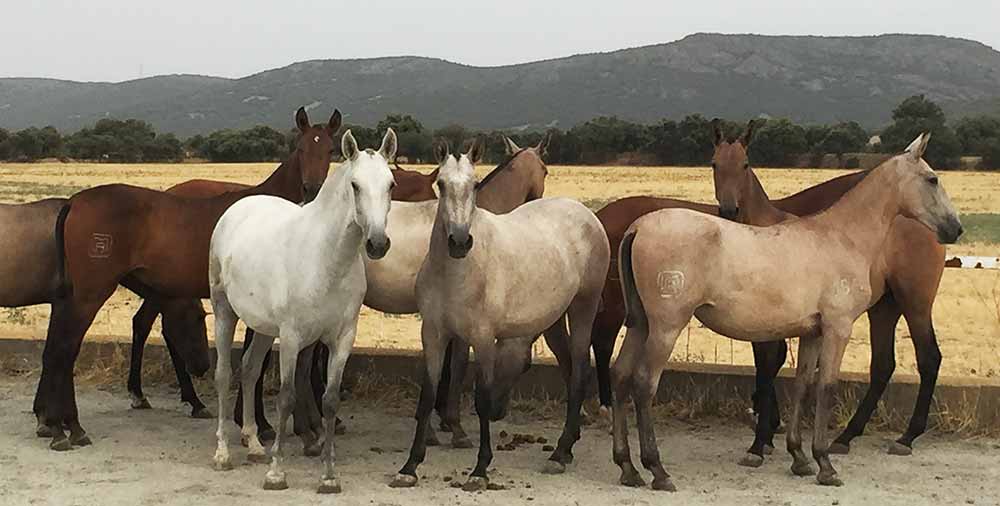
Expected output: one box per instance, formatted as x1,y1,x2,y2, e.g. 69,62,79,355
209,128,396,493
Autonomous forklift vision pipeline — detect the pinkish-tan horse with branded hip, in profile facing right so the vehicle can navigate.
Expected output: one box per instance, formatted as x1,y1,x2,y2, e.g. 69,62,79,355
612,134,962,490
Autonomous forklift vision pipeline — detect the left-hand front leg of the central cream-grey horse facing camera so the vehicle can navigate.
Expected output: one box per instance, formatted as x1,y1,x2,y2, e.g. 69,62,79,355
389,320,447,488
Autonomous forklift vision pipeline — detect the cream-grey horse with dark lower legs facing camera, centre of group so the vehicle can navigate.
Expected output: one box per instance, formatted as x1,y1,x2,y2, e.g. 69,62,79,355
392,138,610,490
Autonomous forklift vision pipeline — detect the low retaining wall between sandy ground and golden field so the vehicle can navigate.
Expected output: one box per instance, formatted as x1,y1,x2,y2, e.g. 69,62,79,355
0,338,1000,434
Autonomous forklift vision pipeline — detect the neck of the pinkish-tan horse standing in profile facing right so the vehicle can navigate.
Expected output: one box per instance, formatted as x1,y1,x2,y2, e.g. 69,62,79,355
807,160,902,259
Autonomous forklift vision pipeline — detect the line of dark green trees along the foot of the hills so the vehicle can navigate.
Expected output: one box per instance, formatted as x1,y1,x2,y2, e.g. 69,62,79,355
0,95,1000,169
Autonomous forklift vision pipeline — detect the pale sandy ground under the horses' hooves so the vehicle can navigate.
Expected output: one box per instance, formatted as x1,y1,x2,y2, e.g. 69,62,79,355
0,376,1000,506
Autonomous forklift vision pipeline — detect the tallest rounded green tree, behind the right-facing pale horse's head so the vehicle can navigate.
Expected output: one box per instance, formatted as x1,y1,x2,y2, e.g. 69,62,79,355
881,95,962,169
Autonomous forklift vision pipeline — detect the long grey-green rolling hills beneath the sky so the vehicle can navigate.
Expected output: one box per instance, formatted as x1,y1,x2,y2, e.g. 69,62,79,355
0,34,1000,136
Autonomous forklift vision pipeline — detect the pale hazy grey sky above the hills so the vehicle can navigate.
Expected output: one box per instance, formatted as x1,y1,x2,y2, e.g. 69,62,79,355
7,0,1000,81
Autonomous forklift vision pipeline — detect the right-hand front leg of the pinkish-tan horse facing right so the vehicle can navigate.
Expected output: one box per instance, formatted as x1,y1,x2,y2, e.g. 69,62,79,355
813,320,853,487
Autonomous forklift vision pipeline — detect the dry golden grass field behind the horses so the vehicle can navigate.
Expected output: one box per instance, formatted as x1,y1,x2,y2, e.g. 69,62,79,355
0,163,1000,377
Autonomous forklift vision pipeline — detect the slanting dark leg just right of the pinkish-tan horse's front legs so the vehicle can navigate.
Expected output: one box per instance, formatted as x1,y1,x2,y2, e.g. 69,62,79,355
830,293,901,455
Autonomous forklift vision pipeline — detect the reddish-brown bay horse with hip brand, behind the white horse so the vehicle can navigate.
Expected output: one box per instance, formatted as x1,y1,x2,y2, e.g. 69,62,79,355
35,109,340,450
